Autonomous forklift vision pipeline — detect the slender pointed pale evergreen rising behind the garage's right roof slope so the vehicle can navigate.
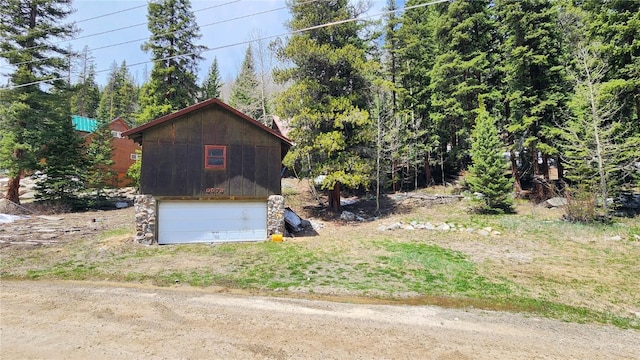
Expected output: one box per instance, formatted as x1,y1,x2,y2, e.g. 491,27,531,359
229,46,267,124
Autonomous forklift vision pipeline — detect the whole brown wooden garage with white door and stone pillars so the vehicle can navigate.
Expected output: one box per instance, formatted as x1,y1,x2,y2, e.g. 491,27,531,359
123,98,293,244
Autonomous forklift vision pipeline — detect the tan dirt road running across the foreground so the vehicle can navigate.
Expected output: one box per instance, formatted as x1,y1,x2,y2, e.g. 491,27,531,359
0,281,640,359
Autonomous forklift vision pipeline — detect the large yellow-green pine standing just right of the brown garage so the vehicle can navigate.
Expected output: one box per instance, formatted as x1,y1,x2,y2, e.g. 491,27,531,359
275,0,373,210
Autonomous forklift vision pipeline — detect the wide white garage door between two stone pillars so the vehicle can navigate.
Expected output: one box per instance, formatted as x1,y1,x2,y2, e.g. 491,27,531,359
157,201,267,244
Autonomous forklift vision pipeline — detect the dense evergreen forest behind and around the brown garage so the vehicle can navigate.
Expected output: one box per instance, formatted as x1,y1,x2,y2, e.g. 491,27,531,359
0,0,640,217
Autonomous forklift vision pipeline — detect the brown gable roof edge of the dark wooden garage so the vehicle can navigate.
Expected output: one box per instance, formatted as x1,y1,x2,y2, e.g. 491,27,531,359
122,98,292,147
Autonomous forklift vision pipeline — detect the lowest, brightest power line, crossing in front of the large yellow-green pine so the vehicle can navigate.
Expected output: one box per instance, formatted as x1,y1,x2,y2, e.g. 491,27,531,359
5,0,452,90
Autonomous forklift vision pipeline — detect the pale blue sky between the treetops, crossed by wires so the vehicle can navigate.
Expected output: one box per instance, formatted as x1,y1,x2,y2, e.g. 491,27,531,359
69,0,289,85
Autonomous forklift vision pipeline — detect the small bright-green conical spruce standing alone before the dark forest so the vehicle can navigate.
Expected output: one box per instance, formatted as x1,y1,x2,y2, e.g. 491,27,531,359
466,104,513,213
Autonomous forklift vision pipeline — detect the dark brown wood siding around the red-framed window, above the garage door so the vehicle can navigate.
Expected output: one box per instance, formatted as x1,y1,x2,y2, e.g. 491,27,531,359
140,107,281,198
